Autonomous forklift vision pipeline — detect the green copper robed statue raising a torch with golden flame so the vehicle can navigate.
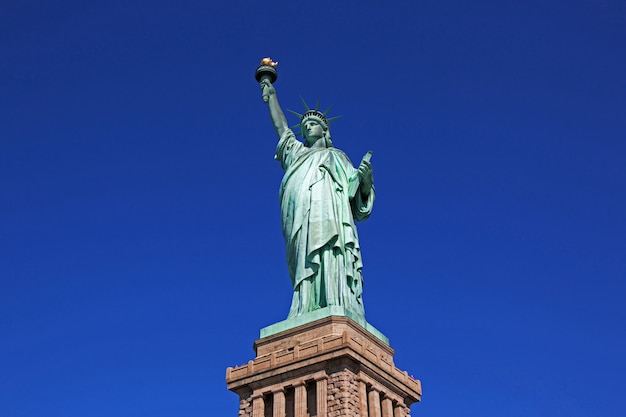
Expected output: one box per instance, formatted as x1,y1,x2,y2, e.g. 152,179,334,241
256,58,374,319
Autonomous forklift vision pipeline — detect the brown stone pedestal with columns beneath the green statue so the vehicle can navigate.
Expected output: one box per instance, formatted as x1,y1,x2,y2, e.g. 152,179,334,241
226,316,422,417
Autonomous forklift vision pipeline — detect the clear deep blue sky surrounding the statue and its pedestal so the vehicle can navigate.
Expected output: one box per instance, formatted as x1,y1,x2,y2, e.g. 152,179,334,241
0,0,626,417
